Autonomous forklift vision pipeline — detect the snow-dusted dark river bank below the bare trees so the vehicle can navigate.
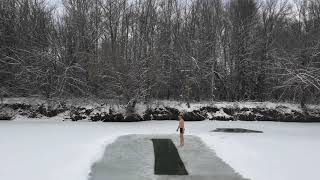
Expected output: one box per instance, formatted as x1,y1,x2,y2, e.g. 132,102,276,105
0,98,320,122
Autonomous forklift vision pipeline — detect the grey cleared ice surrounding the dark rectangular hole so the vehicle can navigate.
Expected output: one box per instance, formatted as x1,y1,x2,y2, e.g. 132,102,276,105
89,135,249,180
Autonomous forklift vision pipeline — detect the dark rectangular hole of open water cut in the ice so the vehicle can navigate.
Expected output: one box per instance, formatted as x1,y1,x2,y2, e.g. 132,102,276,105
152,139,188,175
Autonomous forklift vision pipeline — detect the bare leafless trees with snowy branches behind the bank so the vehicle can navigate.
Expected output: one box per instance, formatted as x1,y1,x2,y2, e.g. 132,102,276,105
0,0,320,105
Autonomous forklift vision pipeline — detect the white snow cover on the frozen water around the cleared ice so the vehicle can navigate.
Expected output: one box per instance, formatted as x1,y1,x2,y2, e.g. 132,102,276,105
0,117,320,180
